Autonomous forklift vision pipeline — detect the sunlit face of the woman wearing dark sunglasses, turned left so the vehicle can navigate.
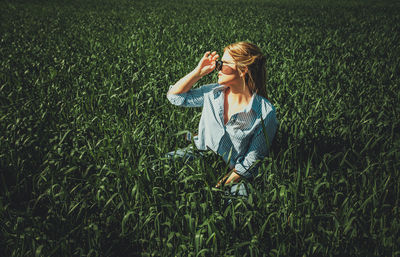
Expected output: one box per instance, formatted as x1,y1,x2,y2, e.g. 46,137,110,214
218,51,242,86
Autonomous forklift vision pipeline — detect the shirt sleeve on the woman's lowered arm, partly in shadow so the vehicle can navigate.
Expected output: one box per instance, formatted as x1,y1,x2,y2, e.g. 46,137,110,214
235,111,278,178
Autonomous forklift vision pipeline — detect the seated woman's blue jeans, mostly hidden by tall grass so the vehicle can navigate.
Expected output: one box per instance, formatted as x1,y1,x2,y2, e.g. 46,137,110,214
165,145,248,197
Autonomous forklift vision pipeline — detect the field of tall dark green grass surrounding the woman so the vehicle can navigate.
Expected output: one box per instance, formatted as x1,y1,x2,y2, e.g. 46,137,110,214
0,0,400,257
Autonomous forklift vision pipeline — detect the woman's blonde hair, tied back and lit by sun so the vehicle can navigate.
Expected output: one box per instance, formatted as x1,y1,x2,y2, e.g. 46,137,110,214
224,41,267,98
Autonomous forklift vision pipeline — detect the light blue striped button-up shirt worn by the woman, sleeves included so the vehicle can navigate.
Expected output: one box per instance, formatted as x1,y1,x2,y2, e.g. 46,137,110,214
167,83,278,178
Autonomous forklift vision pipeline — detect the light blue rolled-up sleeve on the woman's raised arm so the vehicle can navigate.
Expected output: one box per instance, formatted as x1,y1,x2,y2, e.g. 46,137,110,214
167,84,217,107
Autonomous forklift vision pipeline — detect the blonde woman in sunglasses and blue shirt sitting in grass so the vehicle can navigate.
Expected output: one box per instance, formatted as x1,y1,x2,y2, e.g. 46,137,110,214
167,42,278,195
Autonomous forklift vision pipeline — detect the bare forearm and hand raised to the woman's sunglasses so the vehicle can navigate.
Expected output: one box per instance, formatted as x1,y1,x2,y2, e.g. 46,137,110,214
167,51,219,95
